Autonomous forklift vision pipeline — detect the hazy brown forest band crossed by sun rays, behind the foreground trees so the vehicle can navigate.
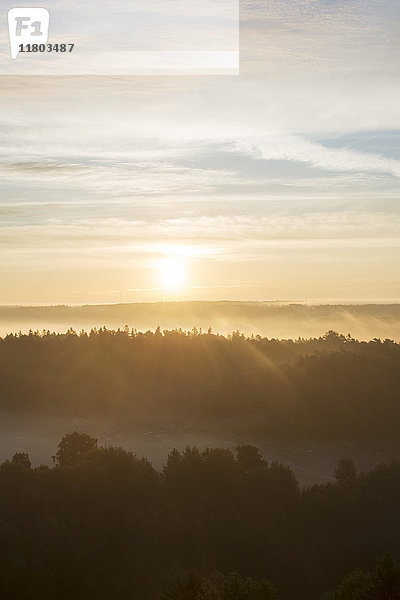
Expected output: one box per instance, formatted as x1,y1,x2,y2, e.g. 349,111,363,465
0,328,400,440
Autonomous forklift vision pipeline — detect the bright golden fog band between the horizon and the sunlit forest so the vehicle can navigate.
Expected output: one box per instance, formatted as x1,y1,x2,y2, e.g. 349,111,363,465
0,302,400,341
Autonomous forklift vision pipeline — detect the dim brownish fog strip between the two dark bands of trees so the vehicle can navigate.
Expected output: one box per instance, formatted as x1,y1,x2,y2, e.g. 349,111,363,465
0,413,400,485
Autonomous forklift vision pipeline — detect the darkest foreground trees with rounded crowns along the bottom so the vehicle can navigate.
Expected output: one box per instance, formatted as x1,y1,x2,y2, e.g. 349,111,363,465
0,432,400,600
